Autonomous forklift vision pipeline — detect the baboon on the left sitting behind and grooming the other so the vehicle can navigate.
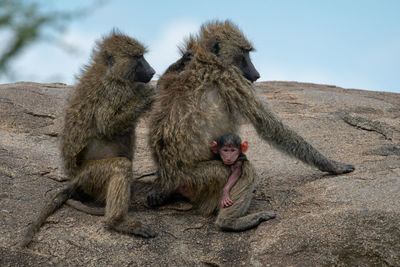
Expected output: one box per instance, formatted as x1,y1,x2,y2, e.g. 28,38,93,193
21,31,155,246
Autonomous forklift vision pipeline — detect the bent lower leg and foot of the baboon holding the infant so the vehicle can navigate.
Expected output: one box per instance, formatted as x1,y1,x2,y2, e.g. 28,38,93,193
215,161,275,231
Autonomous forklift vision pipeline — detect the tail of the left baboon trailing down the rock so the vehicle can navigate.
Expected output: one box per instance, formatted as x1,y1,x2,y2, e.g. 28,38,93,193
19,185,75,247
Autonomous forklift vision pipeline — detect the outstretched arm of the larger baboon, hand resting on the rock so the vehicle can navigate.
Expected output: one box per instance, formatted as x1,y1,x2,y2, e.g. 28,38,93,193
225,85,354,174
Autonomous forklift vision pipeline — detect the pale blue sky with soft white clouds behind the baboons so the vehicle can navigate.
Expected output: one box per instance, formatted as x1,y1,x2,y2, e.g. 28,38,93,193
0,0,400,93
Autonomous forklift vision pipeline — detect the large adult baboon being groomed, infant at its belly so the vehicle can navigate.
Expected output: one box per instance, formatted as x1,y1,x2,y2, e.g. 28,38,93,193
148,21,354,231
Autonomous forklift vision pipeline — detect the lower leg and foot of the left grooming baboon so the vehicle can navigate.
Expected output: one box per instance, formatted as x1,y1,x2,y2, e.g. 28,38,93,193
101,158,155,238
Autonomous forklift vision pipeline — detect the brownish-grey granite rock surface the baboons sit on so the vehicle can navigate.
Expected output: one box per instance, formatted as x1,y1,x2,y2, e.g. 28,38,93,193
0,82,400,266
